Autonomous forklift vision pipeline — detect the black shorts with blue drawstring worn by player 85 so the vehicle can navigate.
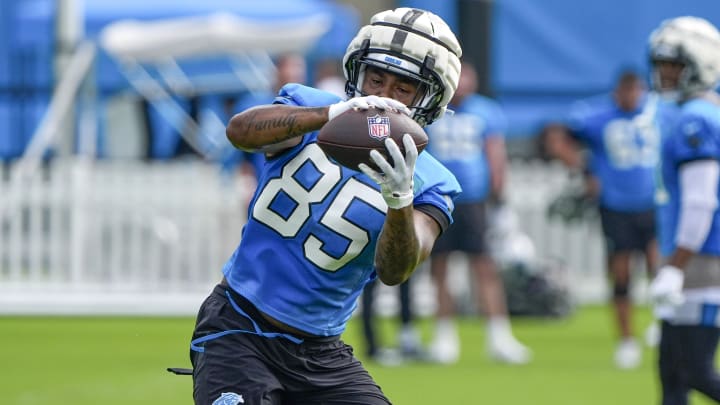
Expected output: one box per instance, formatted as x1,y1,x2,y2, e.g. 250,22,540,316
190,285,390,405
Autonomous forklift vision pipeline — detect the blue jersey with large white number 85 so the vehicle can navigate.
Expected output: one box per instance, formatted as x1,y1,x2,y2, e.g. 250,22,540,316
223,85,460,336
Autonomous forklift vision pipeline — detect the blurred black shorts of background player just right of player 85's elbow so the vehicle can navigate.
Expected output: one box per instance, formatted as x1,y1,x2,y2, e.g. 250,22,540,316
433,203,488,254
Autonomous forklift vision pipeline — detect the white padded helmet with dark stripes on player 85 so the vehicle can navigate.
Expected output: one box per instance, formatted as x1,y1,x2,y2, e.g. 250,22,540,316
343,8,462,126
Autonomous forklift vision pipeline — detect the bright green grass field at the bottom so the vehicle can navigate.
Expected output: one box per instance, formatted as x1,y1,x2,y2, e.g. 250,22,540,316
0,307,711,405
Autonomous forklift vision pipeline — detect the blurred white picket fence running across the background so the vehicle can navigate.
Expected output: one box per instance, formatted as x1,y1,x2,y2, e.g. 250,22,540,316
0,161,620,315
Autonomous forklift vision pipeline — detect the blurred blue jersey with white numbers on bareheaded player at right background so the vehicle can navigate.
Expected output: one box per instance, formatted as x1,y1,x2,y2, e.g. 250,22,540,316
570,94,666,212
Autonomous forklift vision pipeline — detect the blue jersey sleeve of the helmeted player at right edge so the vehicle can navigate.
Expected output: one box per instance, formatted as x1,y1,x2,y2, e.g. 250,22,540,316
670,115,720,165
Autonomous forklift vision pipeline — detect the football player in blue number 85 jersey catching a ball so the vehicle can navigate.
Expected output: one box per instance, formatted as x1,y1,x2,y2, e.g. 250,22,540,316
191,8,461,405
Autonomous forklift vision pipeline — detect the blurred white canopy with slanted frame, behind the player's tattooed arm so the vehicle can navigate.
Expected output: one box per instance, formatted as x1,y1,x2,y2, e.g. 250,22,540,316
99,13,331,159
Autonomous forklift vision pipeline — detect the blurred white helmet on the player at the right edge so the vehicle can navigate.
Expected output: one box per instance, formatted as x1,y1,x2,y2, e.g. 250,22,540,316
649,16,720,99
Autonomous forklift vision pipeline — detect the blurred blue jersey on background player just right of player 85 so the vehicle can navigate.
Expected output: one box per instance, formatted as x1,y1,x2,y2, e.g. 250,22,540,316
427,94,507,203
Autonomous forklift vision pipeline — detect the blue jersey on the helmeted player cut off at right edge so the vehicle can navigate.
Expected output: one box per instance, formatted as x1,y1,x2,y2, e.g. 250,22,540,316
658,99,720,256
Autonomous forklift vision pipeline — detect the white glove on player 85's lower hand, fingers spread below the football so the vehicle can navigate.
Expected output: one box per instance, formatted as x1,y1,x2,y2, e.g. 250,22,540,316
358,134,417,209
